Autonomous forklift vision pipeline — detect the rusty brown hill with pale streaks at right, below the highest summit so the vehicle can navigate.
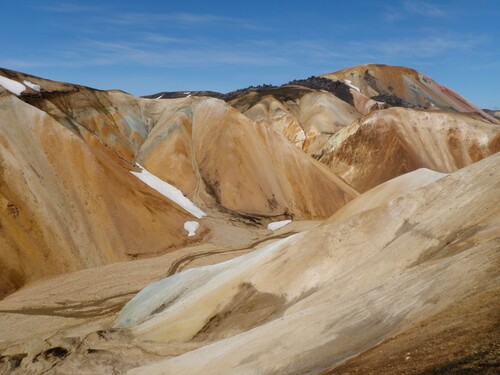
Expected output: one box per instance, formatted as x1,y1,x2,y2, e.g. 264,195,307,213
319,108,500,192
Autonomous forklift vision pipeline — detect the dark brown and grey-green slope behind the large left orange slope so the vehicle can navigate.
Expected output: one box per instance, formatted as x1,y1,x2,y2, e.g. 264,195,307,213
0,69,152,163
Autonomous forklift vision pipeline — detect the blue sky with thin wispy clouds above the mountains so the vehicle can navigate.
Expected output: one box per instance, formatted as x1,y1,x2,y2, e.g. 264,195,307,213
0,0,500,108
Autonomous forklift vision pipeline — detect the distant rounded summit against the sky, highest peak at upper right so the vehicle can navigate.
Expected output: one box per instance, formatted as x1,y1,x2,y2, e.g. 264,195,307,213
323,64,498,123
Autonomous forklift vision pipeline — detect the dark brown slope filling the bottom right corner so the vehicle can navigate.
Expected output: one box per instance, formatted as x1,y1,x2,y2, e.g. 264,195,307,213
321,287,500,375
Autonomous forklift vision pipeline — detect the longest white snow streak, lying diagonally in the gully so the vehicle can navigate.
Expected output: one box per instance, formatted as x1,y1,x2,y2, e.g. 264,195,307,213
130,164,207,219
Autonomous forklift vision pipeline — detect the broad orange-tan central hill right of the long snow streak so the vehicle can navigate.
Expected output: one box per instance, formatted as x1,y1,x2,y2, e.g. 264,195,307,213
139,98,357,219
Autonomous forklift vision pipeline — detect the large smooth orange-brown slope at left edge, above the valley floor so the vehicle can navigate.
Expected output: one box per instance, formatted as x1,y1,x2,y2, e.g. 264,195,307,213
0,94,199,296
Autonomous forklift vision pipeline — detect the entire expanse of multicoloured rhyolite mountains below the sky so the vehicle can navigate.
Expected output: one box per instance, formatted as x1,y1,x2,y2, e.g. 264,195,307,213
0,64,500,374
